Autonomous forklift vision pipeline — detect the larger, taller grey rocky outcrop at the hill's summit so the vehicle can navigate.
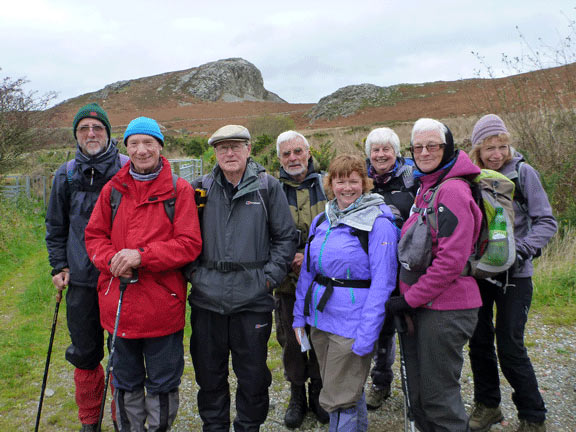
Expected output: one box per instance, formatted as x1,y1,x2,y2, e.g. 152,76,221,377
157,58,286,102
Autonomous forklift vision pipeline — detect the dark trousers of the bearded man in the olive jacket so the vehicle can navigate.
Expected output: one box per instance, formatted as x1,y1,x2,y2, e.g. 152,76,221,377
275,293,322,385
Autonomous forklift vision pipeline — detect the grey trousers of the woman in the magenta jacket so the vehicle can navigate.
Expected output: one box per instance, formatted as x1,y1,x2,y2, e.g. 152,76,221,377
401,308,478,432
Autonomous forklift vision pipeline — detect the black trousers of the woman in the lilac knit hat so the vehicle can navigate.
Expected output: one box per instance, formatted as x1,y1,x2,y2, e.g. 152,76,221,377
470,278,546,422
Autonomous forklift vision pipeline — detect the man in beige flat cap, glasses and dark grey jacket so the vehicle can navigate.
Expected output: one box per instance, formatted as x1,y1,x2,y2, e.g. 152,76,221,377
189,125,296,432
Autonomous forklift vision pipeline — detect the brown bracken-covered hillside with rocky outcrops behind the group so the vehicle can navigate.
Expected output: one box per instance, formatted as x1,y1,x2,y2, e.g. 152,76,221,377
45,58,576,135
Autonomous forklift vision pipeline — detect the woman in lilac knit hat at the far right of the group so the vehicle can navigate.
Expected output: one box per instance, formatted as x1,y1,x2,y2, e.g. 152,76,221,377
470,114,557,432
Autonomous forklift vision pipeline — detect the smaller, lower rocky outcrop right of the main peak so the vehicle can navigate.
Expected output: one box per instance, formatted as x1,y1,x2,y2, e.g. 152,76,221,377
306,84,399,122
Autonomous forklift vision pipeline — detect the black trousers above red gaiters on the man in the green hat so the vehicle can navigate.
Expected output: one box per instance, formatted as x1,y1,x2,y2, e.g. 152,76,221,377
66,285,104,370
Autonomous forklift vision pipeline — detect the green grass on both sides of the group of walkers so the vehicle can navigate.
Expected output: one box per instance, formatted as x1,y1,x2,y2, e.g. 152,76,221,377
0,198,576,431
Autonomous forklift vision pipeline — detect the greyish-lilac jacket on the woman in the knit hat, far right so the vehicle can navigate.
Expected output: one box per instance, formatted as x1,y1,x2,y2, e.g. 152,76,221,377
500,152,558,277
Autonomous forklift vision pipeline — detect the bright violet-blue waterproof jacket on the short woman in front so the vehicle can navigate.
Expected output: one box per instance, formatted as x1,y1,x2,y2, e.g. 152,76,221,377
293,203,399,356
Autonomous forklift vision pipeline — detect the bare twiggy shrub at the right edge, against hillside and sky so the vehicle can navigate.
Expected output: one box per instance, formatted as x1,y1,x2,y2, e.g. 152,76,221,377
471,19,576,222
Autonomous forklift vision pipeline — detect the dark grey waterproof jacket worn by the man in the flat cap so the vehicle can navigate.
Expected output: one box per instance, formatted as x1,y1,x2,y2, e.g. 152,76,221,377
189,159,296,314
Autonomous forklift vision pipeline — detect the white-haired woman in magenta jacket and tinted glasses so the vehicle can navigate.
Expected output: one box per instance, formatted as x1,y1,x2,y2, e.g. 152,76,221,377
386,119,482,432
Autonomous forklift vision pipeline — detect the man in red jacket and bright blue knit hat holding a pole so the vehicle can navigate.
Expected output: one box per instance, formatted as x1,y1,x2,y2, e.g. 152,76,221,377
85,117,202,431
